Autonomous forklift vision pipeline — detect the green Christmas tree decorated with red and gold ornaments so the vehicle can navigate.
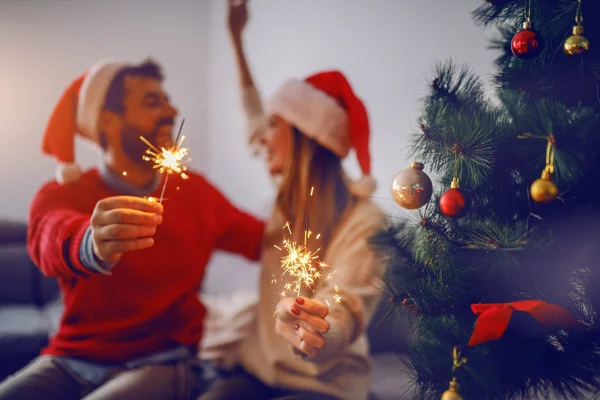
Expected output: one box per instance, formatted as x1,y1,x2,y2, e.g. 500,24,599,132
376,0,600,400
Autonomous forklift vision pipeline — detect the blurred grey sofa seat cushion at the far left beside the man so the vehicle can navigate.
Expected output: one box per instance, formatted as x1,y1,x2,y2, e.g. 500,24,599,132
0,305,49,358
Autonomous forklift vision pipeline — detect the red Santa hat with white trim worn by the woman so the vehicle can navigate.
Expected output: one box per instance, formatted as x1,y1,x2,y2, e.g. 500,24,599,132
266,71,376,196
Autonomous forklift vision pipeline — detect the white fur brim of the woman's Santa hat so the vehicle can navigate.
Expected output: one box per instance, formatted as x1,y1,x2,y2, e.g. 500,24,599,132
266,79,351,158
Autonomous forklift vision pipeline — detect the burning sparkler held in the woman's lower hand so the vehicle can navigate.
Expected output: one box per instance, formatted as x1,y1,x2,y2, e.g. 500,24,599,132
271,187,342,314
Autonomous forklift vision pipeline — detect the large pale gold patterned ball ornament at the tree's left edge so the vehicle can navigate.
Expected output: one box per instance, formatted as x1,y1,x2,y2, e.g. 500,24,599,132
392,162,433,210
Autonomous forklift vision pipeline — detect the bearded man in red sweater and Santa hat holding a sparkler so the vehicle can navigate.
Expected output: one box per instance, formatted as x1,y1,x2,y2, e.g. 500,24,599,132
0,57,264,400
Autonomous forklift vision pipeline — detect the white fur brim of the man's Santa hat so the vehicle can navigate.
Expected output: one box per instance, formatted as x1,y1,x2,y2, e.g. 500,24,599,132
77,60,128,143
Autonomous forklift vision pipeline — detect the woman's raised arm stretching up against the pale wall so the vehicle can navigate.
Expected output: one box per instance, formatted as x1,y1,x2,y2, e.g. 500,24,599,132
228,0,269,150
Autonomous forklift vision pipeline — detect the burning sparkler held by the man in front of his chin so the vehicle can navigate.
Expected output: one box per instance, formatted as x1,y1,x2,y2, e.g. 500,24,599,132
140,118,188,204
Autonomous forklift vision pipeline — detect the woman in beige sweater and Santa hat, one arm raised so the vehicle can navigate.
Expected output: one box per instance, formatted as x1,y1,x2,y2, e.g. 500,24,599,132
200,1,385,400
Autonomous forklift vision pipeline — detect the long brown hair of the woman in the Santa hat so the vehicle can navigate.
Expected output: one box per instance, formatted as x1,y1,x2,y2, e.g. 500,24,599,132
277,128,354,248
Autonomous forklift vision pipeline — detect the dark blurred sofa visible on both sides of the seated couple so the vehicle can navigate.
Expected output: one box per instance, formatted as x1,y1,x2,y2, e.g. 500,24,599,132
0,219,409,400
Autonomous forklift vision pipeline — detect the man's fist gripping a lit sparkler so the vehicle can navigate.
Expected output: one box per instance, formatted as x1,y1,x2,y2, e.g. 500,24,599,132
90,196,163,263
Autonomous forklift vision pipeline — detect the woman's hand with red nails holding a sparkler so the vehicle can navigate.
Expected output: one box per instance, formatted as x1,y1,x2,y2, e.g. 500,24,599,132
275,297,329,357
